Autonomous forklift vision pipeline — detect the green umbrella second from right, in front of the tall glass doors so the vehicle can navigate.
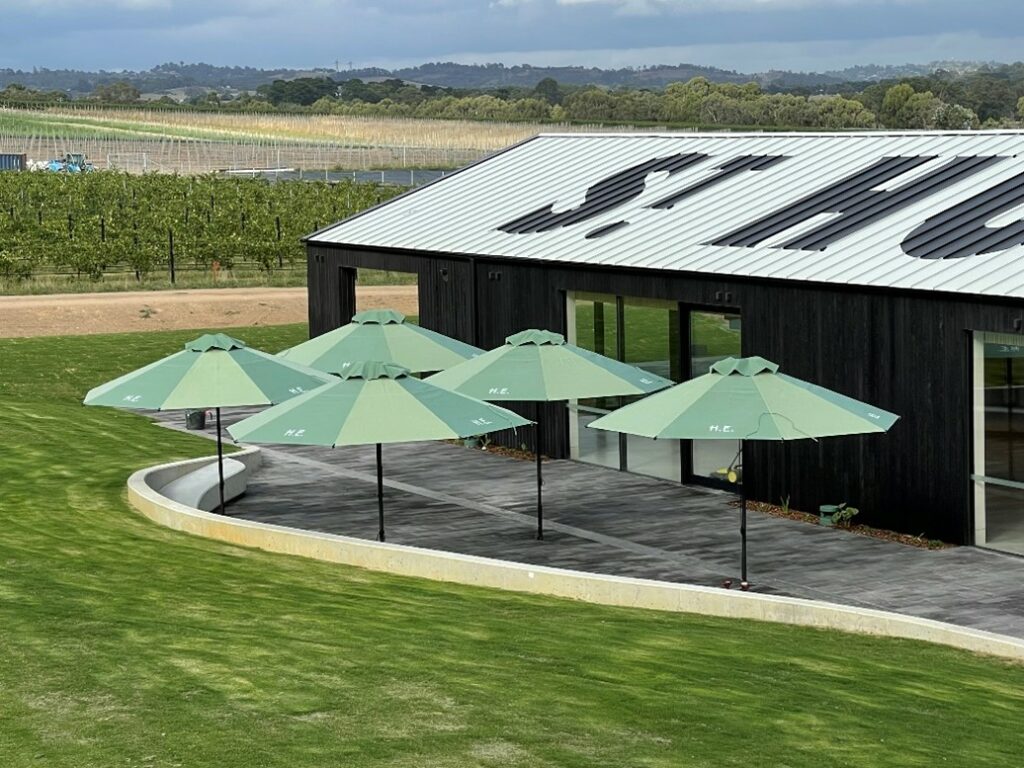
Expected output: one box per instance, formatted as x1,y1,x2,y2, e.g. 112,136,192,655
427,329,672,539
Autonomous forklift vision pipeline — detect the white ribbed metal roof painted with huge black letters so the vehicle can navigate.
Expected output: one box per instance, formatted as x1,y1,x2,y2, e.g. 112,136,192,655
309,131,1024,298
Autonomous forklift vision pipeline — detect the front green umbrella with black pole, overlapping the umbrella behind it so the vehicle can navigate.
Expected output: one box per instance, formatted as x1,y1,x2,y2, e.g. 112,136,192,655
227,362,530,542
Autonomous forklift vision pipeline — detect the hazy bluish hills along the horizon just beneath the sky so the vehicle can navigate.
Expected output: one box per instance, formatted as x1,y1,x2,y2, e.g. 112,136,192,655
0,61,1007,95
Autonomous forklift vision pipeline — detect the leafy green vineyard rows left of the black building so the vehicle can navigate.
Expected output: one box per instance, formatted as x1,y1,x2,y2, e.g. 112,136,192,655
0,172,399,284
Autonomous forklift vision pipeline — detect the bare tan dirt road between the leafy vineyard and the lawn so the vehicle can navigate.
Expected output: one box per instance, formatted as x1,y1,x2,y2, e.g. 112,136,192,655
0,286,417,337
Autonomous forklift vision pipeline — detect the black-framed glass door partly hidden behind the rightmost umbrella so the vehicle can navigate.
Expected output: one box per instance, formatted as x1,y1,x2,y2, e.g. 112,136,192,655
689,310,741,482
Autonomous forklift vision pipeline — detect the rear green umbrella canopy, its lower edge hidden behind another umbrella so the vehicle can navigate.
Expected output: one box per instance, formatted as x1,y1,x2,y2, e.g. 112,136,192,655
280,309,483,374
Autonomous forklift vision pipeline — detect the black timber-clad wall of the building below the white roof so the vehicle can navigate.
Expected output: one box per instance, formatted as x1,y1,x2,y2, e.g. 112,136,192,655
309,246,1024,543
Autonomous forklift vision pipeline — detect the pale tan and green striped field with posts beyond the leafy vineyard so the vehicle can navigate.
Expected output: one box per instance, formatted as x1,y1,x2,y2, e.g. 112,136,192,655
0,109,593,174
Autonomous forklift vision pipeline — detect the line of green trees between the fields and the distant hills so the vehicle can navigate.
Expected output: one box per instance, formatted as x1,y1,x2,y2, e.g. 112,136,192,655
0,65,1024,130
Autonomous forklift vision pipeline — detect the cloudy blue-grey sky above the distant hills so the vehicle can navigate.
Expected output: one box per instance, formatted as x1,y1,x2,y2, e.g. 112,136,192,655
0,0,1024,72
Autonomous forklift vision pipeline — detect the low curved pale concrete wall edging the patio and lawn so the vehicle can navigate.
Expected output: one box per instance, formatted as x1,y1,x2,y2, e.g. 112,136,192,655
128,447,1024,660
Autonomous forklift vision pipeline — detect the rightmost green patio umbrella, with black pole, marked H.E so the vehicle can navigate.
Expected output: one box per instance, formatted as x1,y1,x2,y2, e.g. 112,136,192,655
587,357,899,586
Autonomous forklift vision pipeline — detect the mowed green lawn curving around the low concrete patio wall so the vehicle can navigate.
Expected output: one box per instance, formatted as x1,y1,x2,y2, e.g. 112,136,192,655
0,326,1024,768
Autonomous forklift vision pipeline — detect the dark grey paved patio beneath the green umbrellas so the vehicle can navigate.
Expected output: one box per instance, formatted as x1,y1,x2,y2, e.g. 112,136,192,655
160,413,1024,637
